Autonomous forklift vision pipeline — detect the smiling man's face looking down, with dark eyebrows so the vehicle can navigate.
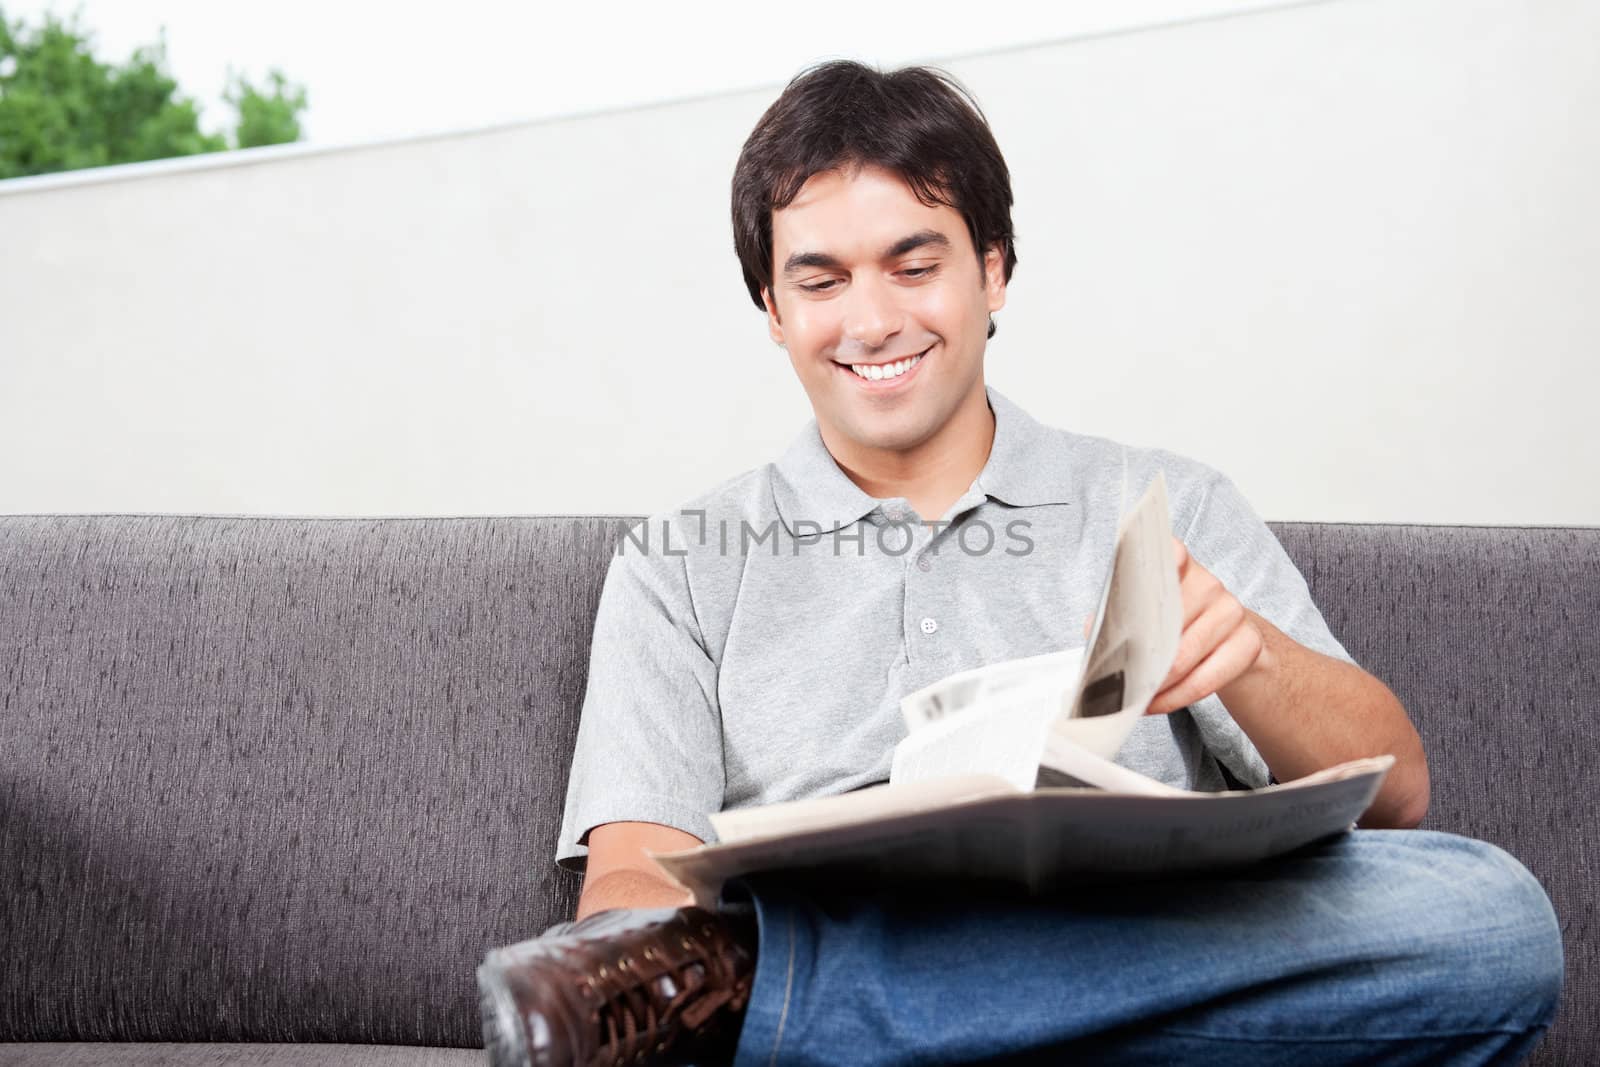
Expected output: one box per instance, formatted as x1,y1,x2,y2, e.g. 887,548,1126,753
763,166,1005,458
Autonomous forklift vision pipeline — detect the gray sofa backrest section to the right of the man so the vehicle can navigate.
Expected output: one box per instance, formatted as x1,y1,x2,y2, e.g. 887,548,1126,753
1272,523,1600,1064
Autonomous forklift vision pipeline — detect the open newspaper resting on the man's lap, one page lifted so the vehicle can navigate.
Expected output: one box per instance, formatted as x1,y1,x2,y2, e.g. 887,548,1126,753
651,477,1394,907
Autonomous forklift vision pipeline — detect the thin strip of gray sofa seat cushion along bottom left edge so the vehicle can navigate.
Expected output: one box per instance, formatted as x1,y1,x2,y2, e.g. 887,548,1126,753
0,1041,483,1067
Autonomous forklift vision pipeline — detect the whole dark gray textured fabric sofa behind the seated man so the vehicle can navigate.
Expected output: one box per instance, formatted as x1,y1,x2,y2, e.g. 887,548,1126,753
0,515,1600,1064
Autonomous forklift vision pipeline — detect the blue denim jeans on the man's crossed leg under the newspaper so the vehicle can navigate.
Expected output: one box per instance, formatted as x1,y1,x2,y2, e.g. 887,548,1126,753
725,830,1562,1067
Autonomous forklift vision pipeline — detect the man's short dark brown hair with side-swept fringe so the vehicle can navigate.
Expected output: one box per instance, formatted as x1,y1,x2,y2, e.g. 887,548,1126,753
733,59,1016,338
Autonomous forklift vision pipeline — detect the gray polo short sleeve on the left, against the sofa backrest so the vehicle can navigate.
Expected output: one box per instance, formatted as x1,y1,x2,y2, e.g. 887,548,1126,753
555,520,725,873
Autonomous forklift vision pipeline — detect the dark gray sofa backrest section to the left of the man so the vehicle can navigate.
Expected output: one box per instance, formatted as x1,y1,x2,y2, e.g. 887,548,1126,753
0,515,621,1046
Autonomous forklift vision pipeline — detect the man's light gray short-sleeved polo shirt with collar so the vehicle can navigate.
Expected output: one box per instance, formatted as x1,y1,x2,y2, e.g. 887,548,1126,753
555,387,1350,872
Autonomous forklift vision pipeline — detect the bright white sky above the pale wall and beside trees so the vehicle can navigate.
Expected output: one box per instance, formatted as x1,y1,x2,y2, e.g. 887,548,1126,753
0,0,1282,144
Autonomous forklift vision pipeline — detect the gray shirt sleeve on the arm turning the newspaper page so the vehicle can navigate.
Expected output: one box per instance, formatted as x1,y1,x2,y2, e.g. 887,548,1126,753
1173,464,1355,787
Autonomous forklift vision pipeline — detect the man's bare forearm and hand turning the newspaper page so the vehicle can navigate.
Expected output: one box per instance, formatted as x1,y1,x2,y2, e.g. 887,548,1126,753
1150,539,1429,827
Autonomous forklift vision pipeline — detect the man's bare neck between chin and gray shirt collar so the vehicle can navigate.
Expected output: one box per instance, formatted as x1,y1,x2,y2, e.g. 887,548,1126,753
824,379,995,520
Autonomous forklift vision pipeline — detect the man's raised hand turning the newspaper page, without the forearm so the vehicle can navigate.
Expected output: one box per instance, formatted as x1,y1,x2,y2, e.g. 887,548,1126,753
1147,537,1269,715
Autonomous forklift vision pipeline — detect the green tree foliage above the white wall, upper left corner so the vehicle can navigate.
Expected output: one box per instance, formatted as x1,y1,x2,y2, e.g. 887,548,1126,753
0,10,306,178
